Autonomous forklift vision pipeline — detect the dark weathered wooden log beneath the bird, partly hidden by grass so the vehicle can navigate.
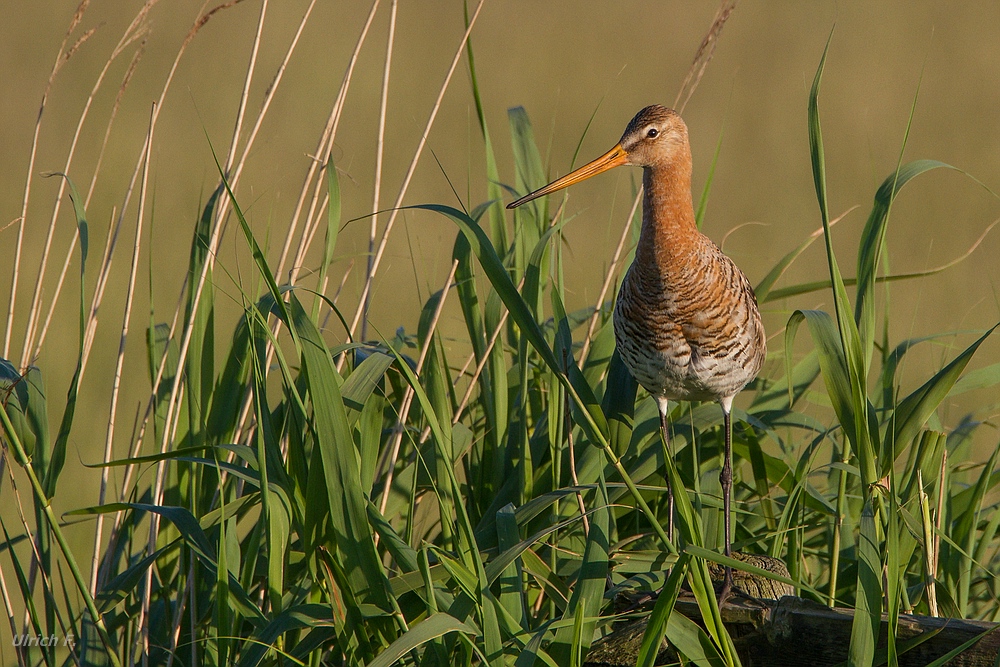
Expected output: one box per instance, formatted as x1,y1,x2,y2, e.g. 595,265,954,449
584,596,1000,667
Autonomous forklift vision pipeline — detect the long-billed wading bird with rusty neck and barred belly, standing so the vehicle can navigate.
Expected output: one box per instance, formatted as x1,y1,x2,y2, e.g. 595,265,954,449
507,104,767,602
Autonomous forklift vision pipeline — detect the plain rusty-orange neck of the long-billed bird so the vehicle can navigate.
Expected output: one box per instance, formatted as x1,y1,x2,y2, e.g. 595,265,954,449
636,159,701,268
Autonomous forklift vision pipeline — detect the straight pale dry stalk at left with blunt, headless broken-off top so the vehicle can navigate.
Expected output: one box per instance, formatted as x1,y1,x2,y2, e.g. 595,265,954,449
90,107,156,597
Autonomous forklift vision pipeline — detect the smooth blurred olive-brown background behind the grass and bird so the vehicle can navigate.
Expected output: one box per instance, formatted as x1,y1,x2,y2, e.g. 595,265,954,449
0,0,1000,520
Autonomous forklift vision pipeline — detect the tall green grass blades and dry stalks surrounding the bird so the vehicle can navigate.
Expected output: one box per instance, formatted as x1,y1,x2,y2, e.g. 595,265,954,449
0,3,1000,667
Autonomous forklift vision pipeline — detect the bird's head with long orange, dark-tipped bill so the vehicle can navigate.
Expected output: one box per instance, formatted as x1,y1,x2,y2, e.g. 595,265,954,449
507,104,690,208
